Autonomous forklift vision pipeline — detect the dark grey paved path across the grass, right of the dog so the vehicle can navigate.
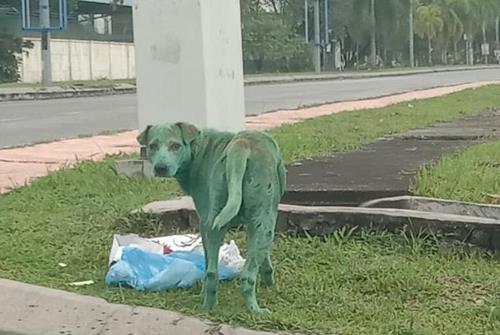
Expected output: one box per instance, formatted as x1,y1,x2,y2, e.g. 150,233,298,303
283,111,500,206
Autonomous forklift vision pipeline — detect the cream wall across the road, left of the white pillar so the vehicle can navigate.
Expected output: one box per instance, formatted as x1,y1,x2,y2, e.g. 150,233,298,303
19,38,135,83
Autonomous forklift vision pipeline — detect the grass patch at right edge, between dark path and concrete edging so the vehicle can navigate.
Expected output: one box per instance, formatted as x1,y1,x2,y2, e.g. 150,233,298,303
413,141,500,204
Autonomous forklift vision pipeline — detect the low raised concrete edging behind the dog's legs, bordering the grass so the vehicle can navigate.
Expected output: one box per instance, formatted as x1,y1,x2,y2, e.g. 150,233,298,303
134,197,500,250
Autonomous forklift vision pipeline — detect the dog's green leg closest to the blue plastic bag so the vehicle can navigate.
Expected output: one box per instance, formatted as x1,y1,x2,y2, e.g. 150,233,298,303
200,224,224,310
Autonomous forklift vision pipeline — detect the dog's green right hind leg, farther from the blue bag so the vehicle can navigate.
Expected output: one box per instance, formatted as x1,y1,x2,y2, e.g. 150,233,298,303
240,215,274,312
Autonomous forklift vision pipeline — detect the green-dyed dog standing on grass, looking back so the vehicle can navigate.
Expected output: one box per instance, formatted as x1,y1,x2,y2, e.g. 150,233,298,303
137,123,286,312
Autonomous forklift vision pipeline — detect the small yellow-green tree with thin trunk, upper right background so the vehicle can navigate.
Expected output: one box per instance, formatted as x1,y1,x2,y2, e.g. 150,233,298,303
415,4,444,65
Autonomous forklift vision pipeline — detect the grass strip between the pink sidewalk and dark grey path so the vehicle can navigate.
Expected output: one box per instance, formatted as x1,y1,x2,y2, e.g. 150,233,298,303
271,85,500,161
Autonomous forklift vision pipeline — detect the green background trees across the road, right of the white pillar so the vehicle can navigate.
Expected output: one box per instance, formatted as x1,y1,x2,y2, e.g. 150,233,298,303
237,0,500,72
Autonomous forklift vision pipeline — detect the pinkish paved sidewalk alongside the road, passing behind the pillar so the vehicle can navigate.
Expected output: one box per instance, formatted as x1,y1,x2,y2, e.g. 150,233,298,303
0,81,500,193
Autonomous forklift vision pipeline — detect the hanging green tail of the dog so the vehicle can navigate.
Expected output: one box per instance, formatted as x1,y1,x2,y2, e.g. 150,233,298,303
213,145,250,230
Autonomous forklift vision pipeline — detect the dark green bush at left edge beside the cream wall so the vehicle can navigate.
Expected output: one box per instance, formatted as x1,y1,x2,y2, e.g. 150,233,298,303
0,34,33,83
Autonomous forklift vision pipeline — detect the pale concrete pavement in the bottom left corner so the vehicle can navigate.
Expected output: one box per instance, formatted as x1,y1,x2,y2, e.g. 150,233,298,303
0,279,278,335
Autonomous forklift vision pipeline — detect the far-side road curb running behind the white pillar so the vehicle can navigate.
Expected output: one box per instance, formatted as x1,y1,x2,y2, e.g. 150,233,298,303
0,65,500,102
